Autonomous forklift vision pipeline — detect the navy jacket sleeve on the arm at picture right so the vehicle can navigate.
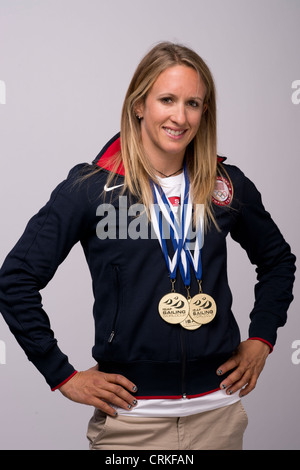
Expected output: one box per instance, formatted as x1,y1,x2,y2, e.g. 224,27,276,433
231,169,296,350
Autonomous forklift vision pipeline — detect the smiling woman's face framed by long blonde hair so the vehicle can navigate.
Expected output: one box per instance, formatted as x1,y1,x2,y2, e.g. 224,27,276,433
137,65,206,167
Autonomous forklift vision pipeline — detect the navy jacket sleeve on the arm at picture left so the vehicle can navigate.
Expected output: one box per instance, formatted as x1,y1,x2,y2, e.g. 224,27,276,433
0,165,86,389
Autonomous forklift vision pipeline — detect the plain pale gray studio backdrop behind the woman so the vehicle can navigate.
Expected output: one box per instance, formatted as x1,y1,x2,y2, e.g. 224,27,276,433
0,0,300,450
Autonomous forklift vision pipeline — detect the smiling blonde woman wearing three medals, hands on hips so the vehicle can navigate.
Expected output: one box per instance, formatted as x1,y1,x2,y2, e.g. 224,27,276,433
1,43,295,449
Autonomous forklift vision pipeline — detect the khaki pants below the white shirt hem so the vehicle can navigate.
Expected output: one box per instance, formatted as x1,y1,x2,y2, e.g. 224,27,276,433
87,401,248,450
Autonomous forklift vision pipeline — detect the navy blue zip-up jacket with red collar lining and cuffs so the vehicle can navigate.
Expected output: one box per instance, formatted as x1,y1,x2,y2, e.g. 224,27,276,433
0,135,295,398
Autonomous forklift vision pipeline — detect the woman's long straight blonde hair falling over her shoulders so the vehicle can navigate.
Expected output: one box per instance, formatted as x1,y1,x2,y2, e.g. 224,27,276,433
105,42,223,229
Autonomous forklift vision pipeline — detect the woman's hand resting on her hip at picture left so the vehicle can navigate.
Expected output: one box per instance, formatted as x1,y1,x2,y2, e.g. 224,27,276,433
59,366,137,416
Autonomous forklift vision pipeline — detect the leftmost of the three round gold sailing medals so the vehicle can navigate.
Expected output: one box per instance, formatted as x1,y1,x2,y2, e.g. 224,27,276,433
158,292,189,325
